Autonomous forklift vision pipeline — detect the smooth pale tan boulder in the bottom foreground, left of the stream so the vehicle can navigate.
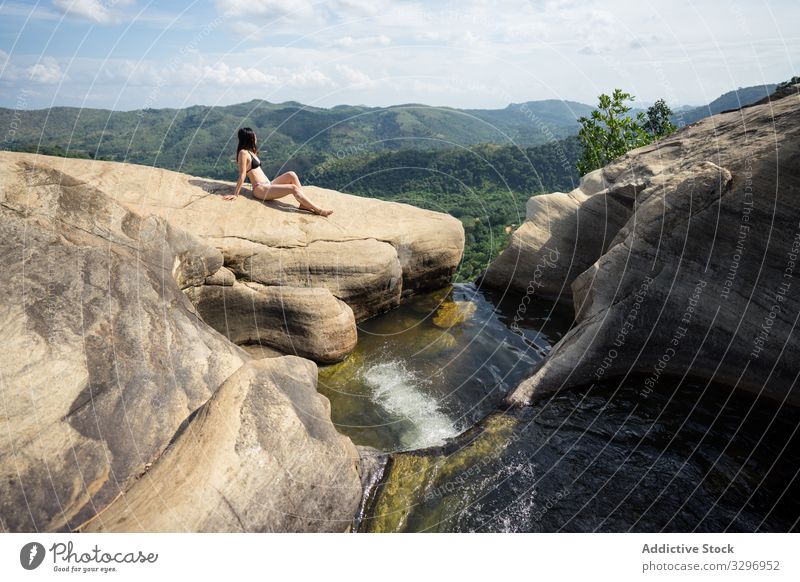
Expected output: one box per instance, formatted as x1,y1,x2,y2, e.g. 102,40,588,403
81,356,362,532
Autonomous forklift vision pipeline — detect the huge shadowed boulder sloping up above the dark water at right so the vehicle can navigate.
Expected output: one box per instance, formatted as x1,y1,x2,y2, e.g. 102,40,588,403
490,87,800,404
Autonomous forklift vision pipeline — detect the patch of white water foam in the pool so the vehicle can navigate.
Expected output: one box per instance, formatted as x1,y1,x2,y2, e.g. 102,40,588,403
363,360,458,449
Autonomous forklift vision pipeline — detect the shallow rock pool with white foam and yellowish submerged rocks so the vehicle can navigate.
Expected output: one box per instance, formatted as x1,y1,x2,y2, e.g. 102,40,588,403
318,284,572,451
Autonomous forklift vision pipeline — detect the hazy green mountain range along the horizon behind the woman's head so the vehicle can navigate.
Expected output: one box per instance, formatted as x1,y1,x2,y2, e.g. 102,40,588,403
0,100,589,178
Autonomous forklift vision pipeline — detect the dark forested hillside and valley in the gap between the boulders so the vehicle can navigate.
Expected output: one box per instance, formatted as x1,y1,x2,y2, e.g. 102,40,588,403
304,136,580,281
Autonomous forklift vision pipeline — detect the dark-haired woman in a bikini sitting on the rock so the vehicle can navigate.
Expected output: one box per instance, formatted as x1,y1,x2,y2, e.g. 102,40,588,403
224,127,333,216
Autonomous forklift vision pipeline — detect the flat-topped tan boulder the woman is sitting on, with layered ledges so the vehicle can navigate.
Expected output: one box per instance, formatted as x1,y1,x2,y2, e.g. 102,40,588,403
0,152,464,362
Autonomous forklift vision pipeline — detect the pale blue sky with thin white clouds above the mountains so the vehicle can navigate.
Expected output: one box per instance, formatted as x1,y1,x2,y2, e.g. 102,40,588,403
0,0,800,110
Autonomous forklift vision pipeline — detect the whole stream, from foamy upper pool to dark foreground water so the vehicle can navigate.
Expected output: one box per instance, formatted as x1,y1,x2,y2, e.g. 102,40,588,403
319,284,800,532
